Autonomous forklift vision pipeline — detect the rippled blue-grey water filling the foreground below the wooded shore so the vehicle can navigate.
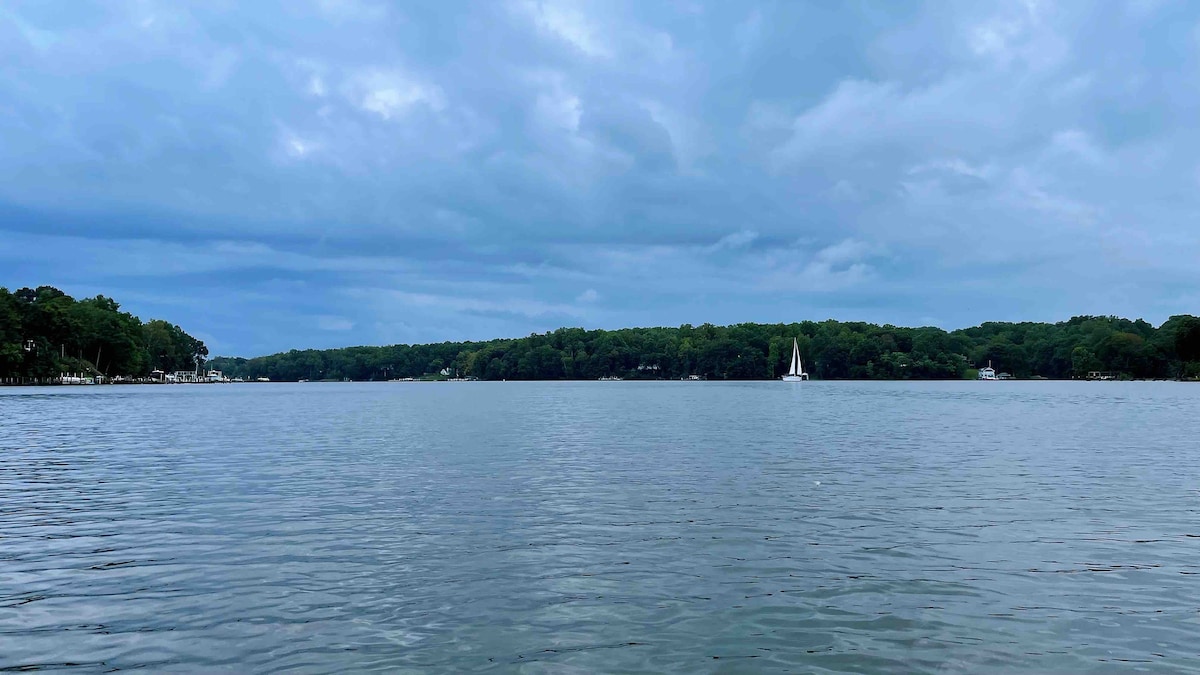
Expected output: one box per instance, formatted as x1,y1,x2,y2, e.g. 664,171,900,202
0,382,1200,673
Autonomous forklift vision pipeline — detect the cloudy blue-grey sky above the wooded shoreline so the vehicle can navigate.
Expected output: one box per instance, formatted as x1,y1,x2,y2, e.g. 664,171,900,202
0,0,1200,357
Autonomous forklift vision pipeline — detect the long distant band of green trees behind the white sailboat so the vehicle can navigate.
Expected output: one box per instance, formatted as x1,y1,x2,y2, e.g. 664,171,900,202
212,316,1200,381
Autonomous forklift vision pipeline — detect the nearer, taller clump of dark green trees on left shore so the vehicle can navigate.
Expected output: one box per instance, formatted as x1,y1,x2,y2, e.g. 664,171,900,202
0,286,209,380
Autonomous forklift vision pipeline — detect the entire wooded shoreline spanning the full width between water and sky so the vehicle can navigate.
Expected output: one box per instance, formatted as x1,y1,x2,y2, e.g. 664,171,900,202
0,286,1200,384
